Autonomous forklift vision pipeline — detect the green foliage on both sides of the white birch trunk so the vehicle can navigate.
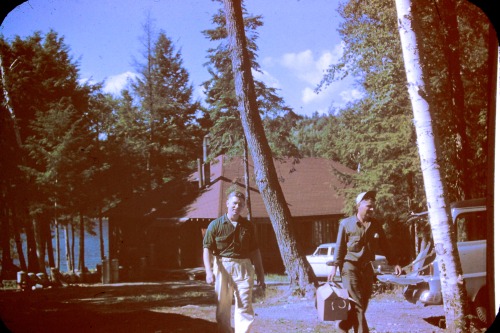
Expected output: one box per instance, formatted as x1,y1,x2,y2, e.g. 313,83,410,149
295,0,488,221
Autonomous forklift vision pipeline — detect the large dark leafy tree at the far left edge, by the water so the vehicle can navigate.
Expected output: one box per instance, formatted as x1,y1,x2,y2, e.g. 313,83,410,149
2,31,94,272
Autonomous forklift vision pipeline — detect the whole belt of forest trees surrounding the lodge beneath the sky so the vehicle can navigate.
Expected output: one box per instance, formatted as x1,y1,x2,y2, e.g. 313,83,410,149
0,0,494,278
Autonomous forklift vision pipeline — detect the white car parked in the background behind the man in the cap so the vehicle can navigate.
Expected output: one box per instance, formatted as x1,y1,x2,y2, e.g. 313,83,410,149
306,243,391,278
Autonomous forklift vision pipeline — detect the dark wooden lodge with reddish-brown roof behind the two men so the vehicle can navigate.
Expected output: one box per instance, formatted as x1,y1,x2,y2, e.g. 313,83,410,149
108,156,354,280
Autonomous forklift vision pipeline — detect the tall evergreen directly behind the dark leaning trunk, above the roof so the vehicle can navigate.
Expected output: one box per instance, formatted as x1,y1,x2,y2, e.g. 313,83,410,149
203,1,300,157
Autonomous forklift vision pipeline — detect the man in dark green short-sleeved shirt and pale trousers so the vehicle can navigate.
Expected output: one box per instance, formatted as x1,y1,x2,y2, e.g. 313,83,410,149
203,191,265,333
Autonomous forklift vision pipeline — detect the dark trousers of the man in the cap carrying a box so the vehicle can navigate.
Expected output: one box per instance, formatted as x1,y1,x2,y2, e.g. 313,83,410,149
340,261,374,333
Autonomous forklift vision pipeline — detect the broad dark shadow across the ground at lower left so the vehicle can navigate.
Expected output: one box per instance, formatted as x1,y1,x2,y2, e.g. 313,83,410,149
0,282,217,333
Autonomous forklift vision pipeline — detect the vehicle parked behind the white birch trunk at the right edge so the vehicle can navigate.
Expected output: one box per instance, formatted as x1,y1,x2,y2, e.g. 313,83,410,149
377,199,488,323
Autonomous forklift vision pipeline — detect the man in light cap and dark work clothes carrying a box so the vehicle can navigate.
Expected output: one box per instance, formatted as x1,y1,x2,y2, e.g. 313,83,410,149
328,191,401,333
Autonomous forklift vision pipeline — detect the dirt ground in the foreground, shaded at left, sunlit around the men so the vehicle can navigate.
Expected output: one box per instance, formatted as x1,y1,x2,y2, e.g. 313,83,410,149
0,281,480,333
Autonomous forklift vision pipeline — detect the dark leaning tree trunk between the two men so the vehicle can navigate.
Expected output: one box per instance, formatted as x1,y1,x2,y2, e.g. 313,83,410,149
224,0,317,296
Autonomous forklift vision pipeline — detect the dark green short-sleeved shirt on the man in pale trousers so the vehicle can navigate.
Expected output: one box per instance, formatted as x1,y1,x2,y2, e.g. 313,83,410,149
203,214,259,259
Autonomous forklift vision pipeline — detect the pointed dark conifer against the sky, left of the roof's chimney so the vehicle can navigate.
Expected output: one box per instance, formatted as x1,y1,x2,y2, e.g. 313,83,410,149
134,24,201,188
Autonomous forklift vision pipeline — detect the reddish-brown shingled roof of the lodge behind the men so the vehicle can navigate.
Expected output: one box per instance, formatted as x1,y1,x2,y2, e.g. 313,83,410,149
184,156,355,219
